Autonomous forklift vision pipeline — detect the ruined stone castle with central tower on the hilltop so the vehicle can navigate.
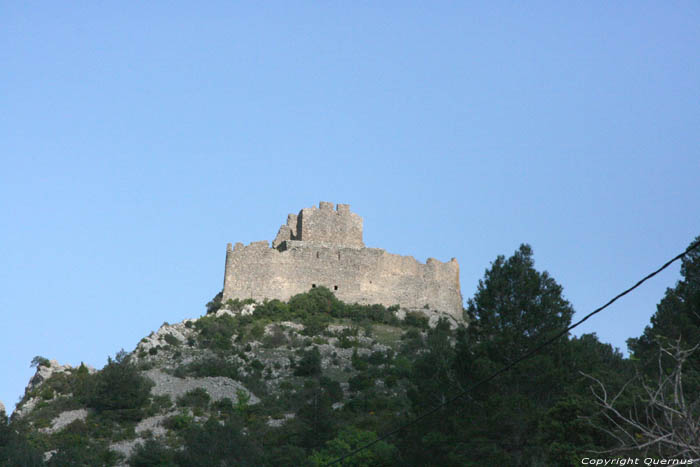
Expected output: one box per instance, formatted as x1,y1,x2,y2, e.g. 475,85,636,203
223,202,462,321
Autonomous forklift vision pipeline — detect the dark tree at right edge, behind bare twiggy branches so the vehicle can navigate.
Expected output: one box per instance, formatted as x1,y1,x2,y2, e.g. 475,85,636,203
586,237,700,459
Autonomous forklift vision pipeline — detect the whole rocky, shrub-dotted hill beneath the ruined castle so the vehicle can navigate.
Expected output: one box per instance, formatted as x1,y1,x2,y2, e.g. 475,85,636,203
4,287,457,465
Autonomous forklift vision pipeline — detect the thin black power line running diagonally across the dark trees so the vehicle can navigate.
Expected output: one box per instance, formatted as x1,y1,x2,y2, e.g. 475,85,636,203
326,240,700,465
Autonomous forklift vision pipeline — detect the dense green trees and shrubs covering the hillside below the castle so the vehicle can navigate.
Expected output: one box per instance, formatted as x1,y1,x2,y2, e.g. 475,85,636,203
0,239,700,466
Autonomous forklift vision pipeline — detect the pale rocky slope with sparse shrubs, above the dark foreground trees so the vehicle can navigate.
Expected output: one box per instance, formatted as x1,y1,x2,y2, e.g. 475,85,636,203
12,290,454,465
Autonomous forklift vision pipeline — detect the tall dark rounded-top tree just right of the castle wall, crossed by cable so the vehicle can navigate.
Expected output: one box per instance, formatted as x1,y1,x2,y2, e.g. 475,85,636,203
453,245,573,465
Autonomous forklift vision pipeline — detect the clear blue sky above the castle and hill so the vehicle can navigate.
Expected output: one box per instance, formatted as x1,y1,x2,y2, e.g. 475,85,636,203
0,1,700,410
